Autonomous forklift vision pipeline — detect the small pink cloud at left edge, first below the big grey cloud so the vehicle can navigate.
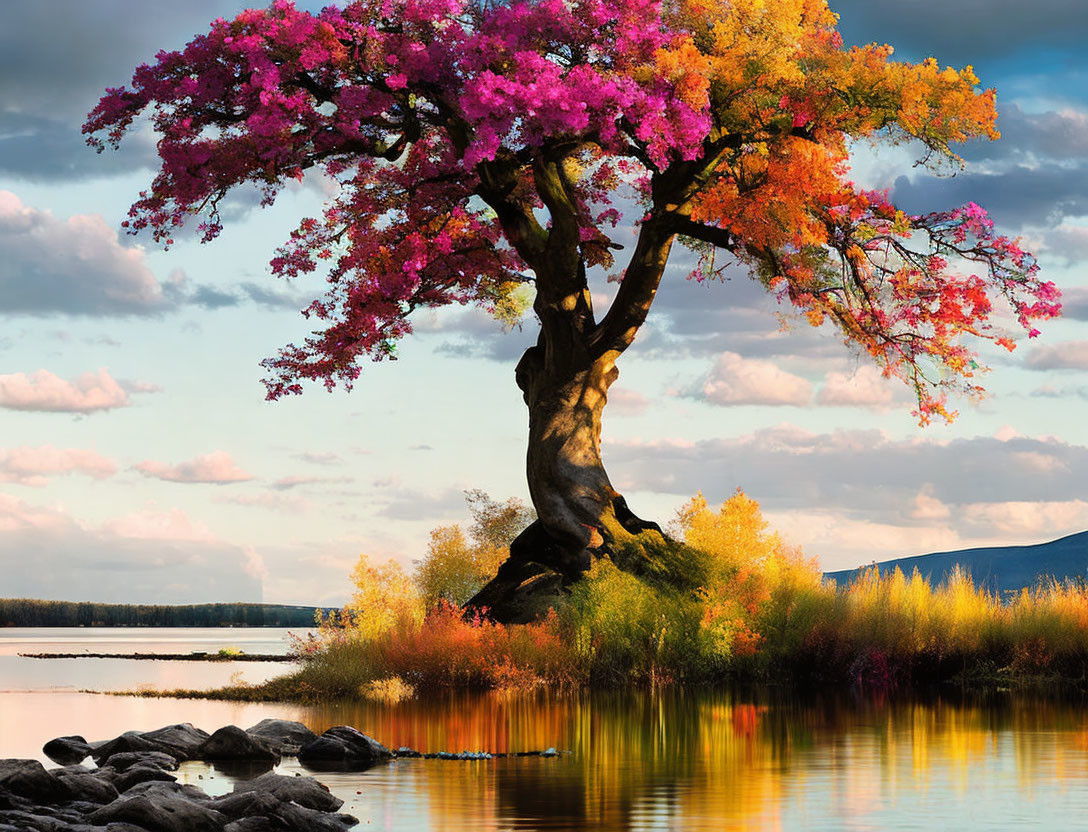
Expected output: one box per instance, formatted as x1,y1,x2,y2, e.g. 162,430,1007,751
0,368,159,413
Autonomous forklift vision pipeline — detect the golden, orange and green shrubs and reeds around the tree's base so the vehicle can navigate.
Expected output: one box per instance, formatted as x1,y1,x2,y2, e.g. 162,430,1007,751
254,490,1088,699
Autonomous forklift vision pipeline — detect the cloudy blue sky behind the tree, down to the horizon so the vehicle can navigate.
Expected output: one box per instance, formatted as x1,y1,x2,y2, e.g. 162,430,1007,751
0,0,1088,604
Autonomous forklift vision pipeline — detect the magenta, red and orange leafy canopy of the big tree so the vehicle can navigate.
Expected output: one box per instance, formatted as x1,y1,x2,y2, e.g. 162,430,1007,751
84,0,1059,417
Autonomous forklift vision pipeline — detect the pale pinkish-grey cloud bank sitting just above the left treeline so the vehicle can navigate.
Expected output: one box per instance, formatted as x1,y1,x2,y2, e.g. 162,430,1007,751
0,494,261,604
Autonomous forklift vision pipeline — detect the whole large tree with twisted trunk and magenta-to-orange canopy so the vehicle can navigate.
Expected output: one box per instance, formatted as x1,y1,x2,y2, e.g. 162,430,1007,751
84,0,1059,617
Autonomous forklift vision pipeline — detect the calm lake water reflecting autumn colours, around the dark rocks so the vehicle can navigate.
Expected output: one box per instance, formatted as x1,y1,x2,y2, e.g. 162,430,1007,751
0,629,1088,832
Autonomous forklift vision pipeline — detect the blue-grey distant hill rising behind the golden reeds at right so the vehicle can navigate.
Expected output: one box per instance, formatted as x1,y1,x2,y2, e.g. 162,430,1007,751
825,532,1088,594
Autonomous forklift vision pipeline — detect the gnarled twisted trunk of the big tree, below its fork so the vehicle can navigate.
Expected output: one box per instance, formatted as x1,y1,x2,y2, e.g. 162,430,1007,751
468,338,663,623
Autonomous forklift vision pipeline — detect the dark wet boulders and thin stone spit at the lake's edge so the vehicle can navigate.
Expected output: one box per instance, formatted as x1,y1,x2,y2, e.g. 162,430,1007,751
0,719,558,832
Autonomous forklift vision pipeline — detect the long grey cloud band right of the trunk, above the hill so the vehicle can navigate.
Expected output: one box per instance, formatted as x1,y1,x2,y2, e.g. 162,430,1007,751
604,425,1088,516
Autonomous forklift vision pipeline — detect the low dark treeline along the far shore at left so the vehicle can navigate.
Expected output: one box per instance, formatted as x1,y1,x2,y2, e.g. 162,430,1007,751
0,598,332,626
